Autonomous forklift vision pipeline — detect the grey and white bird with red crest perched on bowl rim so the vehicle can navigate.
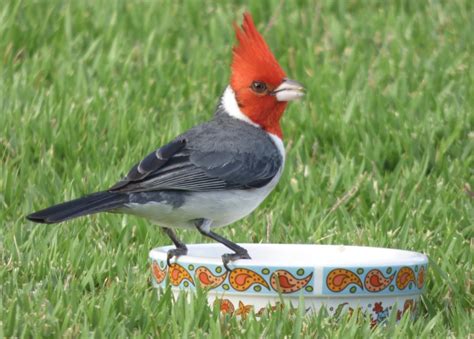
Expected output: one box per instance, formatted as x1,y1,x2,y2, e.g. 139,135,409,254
27,12,305,270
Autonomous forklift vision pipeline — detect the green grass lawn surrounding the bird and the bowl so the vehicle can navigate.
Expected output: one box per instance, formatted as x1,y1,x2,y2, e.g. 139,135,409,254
0,0,474,337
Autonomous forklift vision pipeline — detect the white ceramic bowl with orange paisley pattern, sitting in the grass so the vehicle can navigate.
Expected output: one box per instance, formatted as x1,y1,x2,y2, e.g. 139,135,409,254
149,244,428,324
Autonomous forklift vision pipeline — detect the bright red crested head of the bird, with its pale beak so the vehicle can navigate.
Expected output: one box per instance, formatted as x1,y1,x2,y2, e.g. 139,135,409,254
230,13,303,138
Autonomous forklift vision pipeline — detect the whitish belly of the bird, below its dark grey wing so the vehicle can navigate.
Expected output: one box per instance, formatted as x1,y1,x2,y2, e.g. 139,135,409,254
120,171,281,228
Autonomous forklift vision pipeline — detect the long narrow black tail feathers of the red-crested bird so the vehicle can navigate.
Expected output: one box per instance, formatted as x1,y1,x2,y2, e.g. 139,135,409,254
26,192,128,224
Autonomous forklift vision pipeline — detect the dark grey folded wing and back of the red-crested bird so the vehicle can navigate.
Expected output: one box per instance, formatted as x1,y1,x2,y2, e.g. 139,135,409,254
110,119,282,192
